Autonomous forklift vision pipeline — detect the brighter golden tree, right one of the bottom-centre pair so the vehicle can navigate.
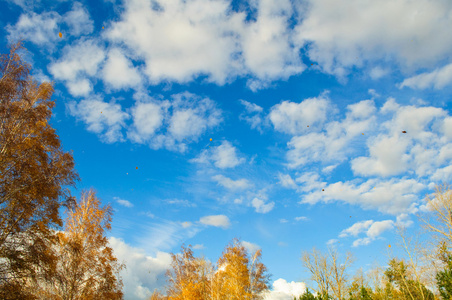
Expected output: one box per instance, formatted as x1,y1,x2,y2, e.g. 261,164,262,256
212,239,269,300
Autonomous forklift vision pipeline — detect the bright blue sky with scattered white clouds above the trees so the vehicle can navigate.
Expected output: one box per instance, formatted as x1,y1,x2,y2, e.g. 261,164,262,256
0,0,452,299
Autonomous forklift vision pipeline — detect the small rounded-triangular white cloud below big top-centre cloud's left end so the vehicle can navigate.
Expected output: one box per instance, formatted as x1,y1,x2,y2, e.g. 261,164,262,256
102,48,141,90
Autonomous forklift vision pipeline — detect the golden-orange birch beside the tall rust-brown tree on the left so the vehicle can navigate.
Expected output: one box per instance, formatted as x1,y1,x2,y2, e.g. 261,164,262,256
32,189,123,300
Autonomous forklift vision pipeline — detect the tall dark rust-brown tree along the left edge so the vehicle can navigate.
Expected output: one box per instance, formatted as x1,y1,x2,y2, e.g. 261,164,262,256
0,43,78,299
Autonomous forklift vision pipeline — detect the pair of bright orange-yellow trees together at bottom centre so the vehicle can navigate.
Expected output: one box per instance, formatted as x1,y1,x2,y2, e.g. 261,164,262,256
162,239,269,300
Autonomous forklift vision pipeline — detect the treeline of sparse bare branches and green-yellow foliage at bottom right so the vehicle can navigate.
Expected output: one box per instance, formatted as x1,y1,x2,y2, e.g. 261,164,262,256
294,185,452,300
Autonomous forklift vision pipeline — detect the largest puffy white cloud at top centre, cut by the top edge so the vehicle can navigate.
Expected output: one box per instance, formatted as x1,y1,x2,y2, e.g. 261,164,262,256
106,0,304,89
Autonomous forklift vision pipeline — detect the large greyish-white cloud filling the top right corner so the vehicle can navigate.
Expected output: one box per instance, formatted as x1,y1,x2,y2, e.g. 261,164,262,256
295,0,452,77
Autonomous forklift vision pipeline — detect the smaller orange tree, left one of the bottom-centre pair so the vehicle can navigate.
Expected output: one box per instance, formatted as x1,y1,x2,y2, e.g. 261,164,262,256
166,245,213,300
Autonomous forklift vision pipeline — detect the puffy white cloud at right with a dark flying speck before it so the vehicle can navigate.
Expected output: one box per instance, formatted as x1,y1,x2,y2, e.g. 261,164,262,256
351,100,446,176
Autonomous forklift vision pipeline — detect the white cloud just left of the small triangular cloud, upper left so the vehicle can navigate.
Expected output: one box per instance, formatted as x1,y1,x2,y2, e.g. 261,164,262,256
49,40,105,97
